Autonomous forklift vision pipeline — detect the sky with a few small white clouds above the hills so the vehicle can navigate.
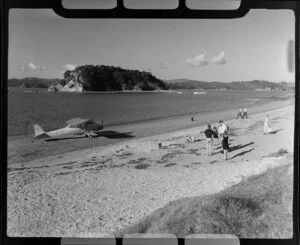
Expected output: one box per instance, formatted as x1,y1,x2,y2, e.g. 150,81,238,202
8,0,295,82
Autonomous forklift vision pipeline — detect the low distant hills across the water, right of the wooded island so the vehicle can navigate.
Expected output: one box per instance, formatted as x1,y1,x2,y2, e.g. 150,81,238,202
164,79,295,90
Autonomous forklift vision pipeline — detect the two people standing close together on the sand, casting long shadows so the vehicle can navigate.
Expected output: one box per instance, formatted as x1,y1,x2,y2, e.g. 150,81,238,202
204,121,230,160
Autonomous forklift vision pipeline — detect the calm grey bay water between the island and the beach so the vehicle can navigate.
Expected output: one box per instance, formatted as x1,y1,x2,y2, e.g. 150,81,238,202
8,90,291,136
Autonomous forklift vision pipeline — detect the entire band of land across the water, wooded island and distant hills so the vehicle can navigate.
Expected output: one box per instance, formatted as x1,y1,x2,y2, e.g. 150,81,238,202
8,65,295,92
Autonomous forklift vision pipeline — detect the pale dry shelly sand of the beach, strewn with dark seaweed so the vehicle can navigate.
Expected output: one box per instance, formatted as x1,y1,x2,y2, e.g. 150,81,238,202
8,102,294,237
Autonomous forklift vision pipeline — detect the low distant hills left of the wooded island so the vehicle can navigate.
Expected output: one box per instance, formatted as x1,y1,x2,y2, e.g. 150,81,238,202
7,77,61,88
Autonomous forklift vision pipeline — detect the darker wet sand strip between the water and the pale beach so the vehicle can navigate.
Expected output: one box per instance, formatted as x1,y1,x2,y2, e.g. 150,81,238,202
8,97,293,165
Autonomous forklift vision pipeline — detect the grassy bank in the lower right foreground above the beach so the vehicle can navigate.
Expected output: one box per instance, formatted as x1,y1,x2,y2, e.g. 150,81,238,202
115,157,293,238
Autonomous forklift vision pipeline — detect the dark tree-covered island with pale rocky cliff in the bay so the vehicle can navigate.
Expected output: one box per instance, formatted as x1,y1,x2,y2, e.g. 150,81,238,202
56,65,168,91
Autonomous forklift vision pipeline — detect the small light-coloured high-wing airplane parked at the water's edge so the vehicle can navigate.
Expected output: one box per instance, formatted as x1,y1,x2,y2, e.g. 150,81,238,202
33,117,103,139
